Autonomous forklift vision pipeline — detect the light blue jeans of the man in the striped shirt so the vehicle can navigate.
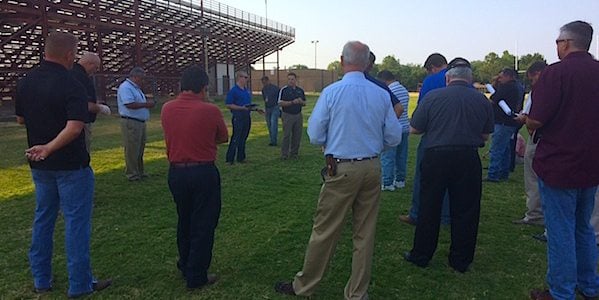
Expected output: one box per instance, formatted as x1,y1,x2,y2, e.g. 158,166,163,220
381,132,409,185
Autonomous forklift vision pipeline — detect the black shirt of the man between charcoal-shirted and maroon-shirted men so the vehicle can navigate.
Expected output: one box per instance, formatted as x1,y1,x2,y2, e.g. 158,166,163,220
491,80,524,127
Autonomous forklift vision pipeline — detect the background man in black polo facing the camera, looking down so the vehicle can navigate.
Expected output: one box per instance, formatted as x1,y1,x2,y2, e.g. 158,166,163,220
279,72,306,160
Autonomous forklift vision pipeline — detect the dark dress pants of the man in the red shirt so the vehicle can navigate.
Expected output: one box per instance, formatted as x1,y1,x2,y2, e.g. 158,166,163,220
168,164,221,288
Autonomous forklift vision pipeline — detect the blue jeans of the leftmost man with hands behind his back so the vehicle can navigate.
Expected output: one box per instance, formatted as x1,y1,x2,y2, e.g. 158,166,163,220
29,167,94,295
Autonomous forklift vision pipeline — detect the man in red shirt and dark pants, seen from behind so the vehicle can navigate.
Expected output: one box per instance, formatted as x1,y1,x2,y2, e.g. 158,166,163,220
161,66,229,289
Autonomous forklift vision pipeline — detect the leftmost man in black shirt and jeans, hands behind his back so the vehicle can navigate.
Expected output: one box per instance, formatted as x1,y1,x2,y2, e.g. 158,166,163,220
15,32,111,297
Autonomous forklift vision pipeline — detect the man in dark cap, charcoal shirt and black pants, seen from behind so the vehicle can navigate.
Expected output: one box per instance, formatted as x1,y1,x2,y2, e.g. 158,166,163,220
404,58,493,272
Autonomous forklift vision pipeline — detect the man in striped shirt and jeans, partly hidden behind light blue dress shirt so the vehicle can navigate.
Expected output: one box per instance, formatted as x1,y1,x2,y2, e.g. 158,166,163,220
377,70,410,191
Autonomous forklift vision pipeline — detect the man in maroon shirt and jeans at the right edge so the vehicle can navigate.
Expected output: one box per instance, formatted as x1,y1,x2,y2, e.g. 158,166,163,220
526,21,599,299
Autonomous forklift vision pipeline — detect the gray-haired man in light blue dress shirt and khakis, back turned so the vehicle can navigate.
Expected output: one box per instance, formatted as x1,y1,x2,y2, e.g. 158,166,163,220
275,41,402,299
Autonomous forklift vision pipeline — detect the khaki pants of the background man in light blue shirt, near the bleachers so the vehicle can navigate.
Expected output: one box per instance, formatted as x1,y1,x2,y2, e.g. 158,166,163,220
121,119,146,180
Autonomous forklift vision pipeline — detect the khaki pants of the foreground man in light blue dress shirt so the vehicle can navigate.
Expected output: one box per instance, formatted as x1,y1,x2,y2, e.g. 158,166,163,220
293,158,381,299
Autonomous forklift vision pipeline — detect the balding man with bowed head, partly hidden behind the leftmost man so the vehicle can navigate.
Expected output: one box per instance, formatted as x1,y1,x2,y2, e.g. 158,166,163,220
71,52,110,154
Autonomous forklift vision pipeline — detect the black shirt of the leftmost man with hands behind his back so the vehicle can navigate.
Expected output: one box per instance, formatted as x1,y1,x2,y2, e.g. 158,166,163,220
15,61,89,170
